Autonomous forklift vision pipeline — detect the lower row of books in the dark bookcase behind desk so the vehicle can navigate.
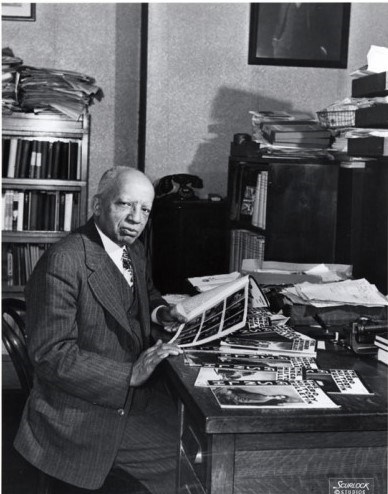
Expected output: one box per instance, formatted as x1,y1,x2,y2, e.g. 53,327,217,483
229,228,265,272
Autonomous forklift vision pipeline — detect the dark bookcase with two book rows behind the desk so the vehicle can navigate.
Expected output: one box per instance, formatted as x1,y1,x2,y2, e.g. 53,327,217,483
228,156,339,271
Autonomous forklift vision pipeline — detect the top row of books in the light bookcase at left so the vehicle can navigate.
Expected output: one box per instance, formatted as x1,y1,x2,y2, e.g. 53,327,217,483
2,137,82,180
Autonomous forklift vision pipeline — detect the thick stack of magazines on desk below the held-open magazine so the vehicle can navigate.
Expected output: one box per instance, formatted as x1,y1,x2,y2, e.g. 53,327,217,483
221,325,317,357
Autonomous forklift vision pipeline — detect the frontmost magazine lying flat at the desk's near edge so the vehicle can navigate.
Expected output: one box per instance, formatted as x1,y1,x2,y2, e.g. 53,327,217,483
209,380,339,409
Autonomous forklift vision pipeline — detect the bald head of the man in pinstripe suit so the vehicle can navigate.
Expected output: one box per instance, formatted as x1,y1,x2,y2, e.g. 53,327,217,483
94,174,154,246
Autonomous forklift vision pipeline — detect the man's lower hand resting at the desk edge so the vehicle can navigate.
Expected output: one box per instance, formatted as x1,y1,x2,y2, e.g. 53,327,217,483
130,340,183,386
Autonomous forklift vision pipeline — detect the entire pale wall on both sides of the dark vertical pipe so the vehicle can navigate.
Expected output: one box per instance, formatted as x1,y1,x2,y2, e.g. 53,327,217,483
2,3,388,201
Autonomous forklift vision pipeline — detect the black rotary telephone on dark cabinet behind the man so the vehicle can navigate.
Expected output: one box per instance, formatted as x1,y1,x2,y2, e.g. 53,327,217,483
155,173,203,201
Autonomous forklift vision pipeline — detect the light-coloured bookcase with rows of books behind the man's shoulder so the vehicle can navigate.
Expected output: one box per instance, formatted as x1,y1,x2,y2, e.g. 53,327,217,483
2,113,90,297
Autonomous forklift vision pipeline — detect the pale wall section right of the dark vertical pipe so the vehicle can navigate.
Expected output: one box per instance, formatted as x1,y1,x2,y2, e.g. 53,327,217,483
146,3,388,195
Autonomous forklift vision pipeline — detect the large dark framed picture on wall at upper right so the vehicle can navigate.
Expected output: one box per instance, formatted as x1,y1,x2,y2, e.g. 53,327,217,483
248,3,350,68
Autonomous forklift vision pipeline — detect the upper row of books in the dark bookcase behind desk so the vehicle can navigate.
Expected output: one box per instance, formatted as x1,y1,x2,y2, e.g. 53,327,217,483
240,171,268,230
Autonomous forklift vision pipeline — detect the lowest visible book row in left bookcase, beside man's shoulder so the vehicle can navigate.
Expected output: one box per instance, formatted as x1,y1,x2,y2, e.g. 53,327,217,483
2,244,51,286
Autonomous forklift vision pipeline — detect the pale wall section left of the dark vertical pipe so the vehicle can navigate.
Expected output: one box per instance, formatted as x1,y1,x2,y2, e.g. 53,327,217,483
2,3,140,211
